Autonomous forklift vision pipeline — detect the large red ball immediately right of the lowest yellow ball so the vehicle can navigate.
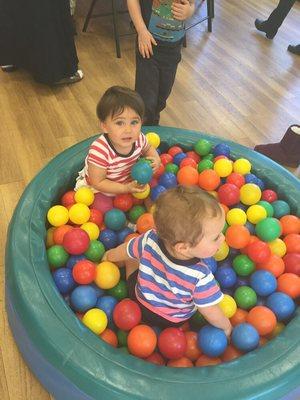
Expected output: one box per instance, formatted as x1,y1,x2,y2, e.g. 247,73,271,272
113,299,142,331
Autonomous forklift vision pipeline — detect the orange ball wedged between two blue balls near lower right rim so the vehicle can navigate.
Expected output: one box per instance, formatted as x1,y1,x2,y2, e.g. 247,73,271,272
247,306,277,336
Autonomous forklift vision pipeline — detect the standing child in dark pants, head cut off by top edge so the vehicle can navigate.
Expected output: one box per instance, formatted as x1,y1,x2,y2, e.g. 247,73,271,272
127,0,195,125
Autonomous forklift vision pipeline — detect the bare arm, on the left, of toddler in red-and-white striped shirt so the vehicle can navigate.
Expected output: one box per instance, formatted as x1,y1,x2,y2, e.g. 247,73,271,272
88,163,145,194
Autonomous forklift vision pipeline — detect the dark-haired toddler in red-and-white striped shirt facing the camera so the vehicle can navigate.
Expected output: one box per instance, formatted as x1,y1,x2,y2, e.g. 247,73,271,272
75,86,161,196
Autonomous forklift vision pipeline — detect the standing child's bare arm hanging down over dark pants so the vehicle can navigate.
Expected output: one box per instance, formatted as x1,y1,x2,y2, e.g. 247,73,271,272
127,0,157,58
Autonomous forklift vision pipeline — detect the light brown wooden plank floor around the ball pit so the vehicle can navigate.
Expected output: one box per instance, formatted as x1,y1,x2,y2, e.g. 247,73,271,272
0,0,300,400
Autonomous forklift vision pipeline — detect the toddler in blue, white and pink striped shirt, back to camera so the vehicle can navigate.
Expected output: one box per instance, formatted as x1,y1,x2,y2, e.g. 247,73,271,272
104,186,232,336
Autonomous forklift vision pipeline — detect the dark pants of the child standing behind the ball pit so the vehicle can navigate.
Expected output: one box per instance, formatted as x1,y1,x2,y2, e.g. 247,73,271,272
135,41,182,125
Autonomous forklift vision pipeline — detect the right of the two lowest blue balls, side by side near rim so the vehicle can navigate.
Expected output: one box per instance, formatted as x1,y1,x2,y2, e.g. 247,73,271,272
231,323,259,352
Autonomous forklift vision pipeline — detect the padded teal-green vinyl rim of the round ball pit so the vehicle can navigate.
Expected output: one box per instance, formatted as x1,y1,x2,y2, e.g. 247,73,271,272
6,127,300,400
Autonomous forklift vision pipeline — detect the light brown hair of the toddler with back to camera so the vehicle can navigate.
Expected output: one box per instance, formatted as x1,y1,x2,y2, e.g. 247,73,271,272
154,185,222,247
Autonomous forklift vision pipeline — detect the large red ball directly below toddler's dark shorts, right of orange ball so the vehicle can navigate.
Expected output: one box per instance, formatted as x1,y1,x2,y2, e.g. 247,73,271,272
158,328,187,360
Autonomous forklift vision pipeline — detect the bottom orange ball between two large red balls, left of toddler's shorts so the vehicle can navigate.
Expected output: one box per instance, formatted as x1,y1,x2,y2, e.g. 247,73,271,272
127,325,157,358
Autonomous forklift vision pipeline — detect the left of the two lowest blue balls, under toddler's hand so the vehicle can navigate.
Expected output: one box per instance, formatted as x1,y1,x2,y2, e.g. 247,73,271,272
198,325,228,357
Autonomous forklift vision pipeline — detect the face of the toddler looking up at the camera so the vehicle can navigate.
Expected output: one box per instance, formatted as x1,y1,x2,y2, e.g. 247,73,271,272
100,108,142,151
